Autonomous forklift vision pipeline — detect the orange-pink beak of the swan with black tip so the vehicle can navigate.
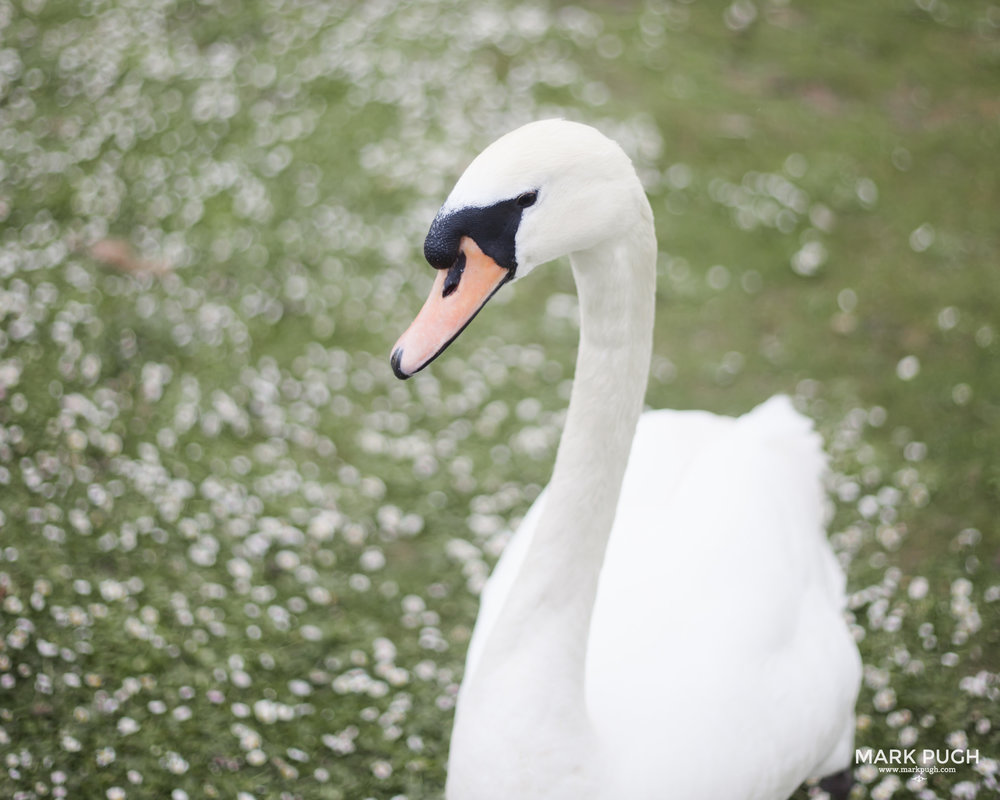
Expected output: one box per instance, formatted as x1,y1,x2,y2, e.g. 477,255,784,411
390,236,513,380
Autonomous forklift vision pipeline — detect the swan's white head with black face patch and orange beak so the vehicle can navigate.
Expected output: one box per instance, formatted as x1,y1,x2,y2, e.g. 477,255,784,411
391,120,648,379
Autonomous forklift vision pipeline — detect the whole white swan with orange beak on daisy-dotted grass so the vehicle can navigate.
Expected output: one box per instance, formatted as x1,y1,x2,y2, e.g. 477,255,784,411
390,120,861,800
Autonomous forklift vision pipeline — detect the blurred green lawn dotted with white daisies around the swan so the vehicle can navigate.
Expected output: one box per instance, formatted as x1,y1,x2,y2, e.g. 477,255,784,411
0,0,1000,800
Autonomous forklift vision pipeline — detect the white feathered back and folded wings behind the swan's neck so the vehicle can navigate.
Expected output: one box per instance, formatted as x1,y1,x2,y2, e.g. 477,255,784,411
587,397,860,798
